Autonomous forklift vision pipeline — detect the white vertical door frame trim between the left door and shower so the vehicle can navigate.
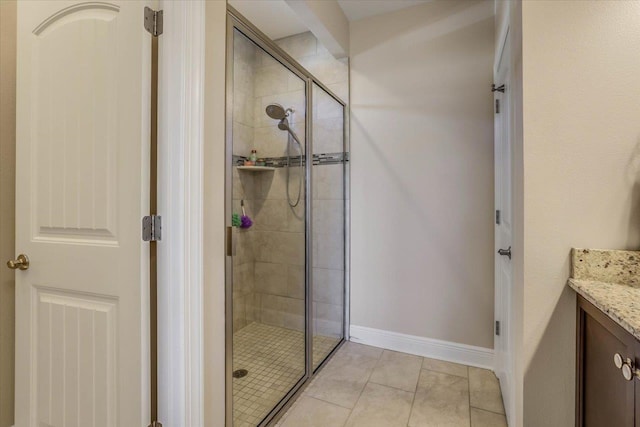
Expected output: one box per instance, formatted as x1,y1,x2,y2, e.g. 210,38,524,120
158,0,204,427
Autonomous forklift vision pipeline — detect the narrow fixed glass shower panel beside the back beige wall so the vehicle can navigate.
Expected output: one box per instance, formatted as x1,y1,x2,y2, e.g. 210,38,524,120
311,83,346,370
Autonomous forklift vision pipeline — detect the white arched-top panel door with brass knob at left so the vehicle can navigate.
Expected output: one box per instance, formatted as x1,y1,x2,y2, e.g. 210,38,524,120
15,0,151,427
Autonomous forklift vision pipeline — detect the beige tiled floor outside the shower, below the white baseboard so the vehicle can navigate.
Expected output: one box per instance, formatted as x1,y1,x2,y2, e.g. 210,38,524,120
277,342,507,427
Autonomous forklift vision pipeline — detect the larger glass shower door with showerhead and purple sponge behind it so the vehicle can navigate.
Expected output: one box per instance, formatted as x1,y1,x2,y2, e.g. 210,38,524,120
227,29,306,427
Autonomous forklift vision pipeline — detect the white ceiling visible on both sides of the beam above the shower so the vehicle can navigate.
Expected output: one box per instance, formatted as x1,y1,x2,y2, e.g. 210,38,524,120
229,0,431,40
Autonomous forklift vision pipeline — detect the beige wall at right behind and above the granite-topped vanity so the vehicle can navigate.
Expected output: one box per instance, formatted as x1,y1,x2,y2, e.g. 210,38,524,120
522,1,640,427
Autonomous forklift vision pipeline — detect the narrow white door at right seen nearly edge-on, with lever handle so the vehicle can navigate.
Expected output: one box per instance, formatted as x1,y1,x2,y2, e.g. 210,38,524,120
494,33,513,422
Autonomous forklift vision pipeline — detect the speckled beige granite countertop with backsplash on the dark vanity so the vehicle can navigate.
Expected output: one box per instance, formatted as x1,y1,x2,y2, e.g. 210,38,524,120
568,249,640,340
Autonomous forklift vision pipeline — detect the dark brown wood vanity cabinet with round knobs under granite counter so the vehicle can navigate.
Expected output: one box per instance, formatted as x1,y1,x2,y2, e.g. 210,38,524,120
576,296,640,427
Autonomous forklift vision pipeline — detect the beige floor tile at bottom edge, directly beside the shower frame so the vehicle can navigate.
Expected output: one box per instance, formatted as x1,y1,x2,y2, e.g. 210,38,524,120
282,396,350,427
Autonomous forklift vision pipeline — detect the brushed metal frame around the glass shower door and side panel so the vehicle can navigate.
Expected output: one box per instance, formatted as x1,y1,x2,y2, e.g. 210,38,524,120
225,5,349,427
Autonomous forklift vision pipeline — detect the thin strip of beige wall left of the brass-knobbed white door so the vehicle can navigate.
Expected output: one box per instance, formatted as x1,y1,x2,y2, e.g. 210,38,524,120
0,0,16,427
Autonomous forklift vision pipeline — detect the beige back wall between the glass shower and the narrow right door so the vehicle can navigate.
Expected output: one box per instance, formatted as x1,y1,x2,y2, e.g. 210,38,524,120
351,1,494,348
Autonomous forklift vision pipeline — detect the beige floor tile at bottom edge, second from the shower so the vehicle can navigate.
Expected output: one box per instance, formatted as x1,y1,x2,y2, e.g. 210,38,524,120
347,383,413,427
